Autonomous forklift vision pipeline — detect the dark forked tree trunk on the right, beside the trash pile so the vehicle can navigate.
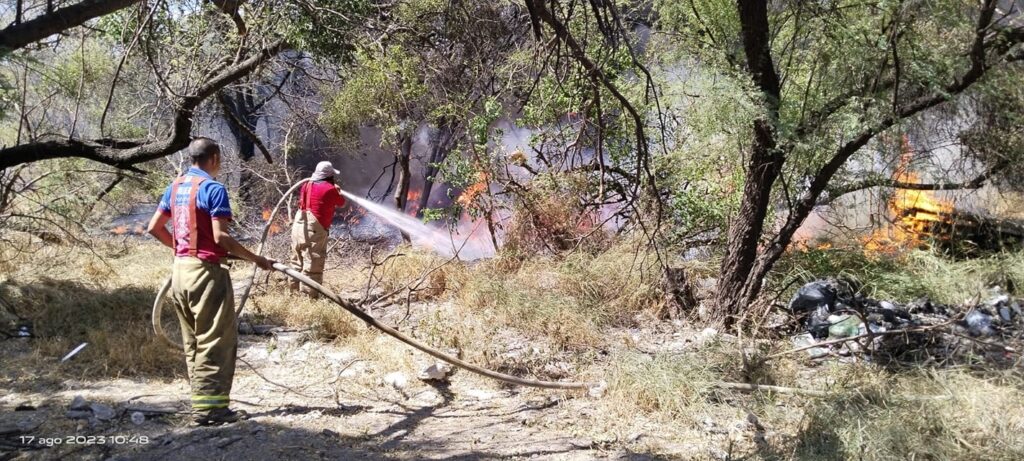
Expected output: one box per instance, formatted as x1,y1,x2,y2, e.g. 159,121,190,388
715,0,1024,324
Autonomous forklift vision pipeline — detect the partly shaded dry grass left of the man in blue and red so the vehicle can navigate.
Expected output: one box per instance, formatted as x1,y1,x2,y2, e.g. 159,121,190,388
0,239,184,376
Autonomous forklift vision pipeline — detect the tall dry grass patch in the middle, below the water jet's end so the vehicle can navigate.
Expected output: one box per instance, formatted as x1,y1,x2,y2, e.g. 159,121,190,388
356,243,664,348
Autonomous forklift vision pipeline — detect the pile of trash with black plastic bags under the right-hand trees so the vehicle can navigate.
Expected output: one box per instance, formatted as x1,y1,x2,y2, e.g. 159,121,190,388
788,279,1024,358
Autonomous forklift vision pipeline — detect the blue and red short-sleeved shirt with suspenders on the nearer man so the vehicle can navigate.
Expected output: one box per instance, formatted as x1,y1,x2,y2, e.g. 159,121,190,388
158,167,231,263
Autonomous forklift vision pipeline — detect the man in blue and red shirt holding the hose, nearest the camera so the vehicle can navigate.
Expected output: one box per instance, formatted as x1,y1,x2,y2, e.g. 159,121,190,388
148,137,273,425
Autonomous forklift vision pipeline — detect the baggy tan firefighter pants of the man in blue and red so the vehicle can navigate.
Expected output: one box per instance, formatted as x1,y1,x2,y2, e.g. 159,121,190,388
171,257,239,411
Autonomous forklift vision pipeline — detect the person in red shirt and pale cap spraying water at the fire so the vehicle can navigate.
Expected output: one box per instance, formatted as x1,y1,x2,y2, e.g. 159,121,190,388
290,162,345,298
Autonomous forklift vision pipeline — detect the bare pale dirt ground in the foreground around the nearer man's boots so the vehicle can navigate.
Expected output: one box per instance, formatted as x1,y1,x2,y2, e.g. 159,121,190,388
0,313,724,460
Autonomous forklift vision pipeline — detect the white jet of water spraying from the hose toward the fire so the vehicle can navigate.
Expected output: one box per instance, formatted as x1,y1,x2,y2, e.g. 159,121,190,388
341,190,495,260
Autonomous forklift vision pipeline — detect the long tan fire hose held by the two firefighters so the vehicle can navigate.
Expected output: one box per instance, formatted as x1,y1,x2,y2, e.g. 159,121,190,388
153,179,597,389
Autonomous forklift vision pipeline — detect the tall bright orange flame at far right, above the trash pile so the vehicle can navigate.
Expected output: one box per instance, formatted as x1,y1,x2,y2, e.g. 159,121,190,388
861,135,953,254
